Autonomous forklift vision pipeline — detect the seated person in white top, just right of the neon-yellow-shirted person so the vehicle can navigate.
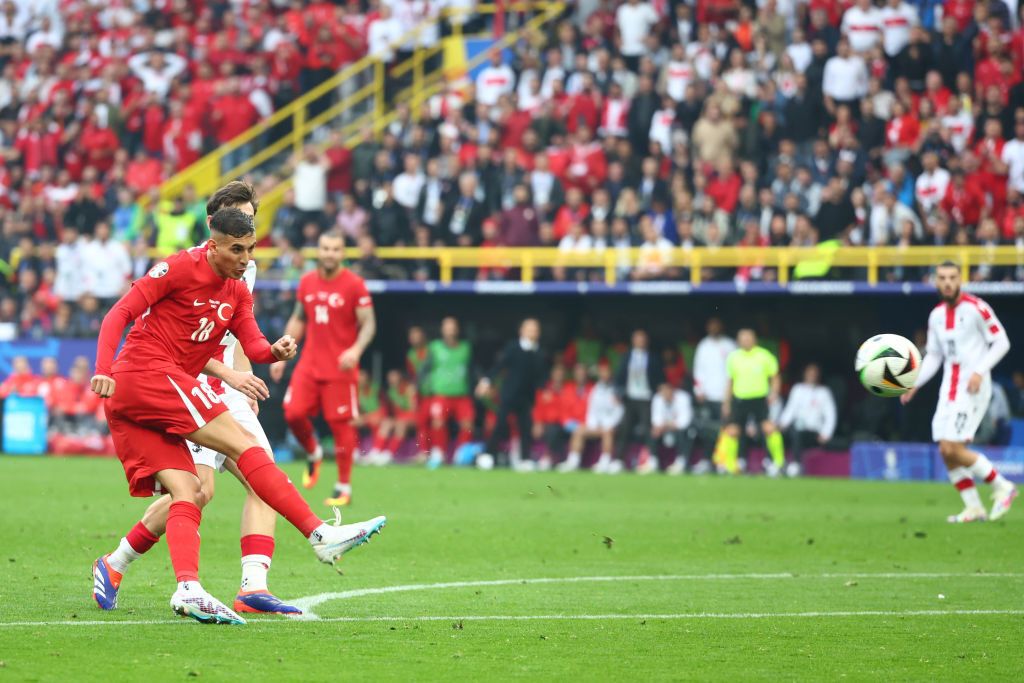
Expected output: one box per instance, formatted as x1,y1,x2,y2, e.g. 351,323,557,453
778,362,836,476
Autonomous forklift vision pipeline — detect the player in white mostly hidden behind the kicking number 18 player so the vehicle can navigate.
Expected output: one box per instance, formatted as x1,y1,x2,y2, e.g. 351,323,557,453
93,181,302,615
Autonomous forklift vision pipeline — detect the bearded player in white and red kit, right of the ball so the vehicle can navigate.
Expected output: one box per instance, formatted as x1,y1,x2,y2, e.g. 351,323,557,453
900,261,1017,523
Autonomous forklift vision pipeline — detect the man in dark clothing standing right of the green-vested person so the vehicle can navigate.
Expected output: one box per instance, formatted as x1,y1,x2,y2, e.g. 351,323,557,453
476,317,545,467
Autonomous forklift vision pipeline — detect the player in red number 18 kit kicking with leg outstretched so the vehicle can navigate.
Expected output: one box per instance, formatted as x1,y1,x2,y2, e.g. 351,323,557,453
91,208,386,624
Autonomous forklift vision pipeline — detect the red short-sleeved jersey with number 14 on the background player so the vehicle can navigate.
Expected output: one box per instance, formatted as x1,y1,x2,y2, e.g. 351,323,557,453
296,269,374,382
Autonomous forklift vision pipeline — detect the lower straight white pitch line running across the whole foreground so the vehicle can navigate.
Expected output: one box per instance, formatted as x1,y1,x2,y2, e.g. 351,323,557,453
0,609,1024,628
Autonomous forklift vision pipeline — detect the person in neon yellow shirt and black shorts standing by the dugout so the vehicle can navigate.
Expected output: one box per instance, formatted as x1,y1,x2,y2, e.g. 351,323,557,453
714,329,785,476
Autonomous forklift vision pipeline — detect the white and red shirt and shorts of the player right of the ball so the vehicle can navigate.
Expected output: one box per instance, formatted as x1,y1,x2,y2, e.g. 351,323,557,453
915,294,1010,443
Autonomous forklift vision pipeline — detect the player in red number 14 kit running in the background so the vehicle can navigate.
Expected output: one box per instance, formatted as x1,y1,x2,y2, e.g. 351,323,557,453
270,232,377,505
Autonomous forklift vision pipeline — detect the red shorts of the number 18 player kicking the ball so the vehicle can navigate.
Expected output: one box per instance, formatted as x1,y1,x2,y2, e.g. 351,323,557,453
105,369,227,497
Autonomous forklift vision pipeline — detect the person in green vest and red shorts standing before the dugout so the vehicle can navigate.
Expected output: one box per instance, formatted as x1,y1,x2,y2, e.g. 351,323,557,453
420,316,475,469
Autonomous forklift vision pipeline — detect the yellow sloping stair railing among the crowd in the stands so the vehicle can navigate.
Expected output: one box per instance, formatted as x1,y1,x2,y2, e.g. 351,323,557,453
161,2,564,237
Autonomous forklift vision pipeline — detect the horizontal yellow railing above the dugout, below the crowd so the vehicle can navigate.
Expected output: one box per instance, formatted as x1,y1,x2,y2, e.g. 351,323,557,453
134,246,1024,285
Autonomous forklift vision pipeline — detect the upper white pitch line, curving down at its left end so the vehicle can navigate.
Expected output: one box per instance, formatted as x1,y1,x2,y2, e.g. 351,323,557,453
291,571,1024,620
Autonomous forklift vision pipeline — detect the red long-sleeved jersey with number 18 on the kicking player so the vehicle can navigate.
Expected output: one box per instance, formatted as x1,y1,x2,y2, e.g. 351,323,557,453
96,247,273,377
